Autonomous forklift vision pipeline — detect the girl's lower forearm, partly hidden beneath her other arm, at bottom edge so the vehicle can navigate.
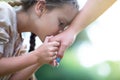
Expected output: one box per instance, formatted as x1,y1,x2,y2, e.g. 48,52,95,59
10,64,42,80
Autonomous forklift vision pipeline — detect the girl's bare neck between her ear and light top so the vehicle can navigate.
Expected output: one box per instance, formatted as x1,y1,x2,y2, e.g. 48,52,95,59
17,8,42,39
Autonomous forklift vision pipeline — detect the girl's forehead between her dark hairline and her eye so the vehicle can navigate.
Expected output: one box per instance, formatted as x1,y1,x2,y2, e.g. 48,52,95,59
48,4,78,23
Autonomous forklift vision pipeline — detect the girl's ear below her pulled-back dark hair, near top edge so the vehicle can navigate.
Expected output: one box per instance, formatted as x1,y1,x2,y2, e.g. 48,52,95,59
35,0,46,17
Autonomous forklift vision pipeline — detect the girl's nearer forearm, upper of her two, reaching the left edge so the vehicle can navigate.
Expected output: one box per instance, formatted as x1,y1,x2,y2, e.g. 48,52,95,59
0,54,37,76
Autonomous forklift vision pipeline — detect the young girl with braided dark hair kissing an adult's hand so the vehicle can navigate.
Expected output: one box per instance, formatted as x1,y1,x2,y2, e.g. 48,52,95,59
0,0,78,80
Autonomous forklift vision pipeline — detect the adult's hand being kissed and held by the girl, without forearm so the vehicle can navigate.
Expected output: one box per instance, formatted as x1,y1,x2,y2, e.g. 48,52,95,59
50,30,76,62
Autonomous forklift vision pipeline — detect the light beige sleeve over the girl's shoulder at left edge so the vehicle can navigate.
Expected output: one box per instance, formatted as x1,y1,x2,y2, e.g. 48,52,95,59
0,1,17,41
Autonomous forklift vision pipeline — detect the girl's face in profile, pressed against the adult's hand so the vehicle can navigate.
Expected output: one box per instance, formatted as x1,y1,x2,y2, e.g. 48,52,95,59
35,5,78,41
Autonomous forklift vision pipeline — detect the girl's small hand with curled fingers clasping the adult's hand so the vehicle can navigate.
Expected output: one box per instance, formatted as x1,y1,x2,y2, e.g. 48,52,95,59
34,37,60,64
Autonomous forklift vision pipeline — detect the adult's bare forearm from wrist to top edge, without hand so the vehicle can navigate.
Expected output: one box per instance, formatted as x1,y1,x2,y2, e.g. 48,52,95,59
68,0,116,34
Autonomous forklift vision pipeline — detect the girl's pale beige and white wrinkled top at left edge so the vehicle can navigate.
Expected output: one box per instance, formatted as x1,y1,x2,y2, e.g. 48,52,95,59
0,1,22,80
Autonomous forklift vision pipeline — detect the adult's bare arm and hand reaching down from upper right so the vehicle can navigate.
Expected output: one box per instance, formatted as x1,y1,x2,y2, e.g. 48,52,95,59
52,0,116,58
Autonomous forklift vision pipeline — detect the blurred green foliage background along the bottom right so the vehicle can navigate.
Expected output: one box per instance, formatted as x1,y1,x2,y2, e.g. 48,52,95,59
36,51,120,80
